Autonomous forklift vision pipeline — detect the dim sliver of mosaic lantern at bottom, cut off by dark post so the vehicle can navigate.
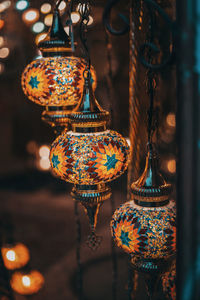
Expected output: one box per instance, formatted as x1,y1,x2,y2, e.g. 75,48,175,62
162,261,176,300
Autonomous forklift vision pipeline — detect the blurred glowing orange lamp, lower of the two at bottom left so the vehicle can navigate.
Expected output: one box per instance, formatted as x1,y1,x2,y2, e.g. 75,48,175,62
10,270,44,295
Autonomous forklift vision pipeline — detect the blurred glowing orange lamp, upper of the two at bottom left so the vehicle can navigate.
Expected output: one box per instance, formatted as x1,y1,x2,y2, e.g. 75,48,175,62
1,243,30,270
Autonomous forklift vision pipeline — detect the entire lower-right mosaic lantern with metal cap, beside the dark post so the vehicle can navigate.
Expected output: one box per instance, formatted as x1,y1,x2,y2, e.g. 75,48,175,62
111,146,176,294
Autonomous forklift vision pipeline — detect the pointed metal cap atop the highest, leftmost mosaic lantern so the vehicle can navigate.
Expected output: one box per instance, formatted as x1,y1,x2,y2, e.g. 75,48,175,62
38,8,73,56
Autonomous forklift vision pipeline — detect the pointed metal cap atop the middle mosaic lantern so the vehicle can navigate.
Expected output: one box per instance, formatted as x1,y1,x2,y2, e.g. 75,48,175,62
70,72,109,132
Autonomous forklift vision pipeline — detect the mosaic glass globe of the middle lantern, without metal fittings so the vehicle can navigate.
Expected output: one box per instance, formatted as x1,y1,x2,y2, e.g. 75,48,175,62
50,130,129,185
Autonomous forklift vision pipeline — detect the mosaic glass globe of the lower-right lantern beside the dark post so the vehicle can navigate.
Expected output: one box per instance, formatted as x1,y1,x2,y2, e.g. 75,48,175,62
111,201,176,259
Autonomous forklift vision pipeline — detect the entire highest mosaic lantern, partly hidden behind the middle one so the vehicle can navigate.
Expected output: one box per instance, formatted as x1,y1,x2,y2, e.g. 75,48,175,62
21,9,96,131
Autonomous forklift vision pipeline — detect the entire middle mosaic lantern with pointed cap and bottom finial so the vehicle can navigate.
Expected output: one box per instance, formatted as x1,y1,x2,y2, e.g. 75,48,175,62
50,73,129,248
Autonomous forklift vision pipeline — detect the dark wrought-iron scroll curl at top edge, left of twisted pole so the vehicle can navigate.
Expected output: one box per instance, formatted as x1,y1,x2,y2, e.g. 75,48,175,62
103,0,129,35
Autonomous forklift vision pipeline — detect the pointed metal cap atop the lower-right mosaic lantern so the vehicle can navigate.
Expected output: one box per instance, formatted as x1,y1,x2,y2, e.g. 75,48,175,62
131,144,172,206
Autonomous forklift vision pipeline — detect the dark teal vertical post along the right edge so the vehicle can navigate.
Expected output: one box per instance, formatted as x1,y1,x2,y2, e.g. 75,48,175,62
176,0,200,300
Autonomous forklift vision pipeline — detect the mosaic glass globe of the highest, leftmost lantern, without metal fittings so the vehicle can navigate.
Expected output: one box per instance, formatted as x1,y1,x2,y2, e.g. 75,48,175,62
21,57,96,106
